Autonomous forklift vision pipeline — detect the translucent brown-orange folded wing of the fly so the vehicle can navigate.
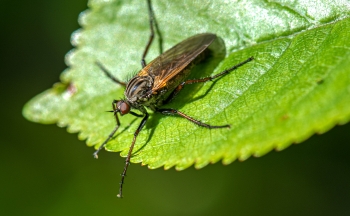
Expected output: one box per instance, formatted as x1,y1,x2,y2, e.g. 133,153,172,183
138,33,216,91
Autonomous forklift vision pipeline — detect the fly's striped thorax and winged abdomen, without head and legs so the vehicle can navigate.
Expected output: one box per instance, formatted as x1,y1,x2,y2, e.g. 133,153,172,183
125,34,216,111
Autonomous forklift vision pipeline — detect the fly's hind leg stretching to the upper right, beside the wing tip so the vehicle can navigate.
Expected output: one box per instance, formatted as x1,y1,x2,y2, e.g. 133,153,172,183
164,57,254,104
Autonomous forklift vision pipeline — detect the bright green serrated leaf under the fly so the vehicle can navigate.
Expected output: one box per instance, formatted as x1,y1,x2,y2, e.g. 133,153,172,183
23,0,350,170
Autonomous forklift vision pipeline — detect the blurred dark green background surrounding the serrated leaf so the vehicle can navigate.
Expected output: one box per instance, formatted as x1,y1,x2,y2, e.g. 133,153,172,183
0,0,350,215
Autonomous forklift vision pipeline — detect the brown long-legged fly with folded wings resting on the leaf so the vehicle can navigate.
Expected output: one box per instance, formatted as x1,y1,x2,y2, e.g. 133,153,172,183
94,0,253,197
